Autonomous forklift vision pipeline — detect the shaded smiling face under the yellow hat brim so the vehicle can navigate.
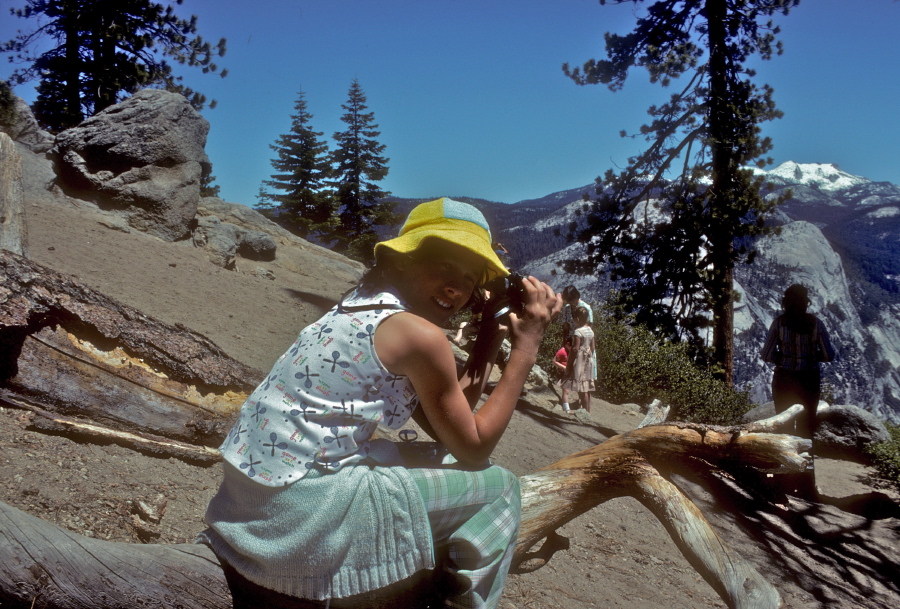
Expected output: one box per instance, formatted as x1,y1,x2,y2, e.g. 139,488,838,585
397,239,485,325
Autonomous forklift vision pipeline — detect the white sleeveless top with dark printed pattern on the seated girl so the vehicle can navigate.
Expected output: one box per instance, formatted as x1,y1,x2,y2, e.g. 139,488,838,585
220,292,418,486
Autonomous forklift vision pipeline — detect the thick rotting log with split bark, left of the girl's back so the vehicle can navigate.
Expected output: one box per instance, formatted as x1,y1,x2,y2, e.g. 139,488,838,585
0,252,262,446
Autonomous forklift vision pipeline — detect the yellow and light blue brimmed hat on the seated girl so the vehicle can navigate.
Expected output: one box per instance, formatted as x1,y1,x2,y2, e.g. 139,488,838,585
375,197,509,280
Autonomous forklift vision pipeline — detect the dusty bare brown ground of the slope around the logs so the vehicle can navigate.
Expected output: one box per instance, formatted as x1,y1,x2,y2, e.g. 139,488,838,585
0,197,900,609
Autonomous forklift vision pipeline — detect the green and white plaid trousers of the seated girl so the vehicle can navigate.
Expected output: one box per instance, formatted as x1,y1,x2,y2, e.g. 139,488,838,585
409,465,522,609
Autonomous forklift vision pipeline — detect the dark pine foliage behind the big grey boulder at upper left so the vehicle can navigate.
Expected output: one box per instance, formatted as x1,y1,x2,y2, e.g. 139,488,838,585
0,0,227,132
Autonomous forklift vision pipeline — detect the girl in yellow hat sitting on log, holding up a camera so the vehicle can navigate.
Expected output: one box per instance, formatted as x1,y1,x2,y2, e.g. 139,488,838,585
201,198,562,607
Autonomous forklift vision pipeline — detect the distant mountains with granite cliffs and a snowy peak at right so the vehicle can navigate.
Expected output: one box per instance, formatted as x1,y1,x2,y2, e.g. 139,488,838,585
388,161,900,422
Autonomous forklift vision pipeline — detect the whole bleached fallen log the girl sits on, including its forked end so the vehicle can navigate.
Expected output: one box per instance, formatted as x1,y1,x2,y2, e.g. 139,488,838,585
0,424,807,609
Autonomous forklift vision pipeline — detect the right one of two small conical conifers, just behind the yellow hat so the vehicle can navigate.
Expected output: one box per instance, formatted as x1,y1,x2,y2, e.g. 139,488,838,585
331,79,395,262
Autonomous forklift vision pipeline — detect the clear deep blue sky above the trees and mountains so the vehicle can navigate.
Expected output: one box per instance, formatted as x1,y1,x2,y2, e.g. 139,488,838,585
0,0,900,205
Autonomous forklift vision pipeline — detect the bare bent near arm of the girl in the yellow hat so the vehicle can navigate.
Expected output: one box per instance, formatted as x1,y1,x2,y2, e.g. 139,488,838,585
375,277,562,465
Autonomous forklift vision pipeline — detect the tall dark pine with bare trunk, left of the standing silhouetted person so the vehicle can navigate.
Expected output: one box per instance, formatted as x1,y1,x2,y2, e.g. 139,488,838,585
563,0,799,384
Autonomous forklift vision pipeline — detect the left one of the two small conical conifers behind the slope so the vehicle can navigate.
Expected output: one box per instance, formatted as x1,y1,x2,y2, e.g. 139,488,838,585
257,91,336,238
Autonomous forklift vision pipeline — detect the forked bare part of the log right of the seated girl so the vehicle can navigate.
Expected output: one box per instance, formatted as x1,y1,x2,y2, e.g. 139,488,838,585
516,423,810,607
